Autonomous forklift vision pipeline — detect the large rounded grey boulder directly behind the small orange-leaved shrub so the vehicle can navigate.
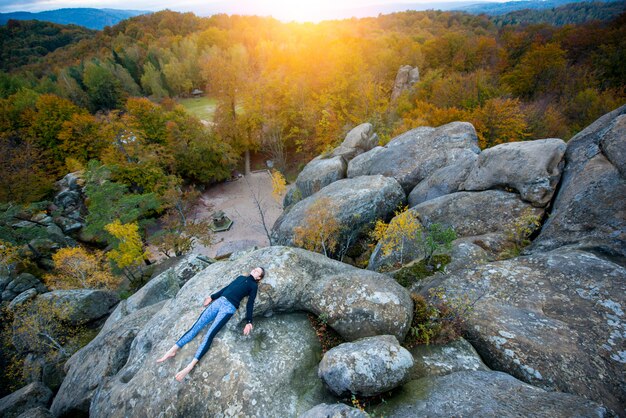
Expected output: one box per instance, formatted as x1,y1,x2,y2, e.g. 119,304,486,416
272,175,405,250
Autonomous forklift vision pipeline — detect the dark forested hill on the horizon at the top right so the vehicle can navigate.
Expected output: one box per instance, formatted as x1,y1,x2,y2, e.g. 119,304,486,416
491,2,626,27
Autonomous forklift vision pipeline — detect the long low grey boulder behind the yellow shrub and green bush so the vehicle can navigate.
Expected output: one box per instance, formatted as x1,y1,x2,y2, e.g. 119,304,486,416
368,190,544,271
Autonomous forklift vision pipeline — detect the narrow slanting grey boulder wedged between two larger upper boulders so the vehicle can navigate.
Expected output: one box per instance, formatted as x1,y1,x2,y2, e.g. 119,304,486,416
408,153,478,207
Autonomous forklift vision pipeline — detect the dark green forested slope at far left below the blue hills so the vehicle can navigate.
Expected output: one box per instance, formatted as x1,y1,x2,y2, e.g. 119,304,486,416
0,20,97,71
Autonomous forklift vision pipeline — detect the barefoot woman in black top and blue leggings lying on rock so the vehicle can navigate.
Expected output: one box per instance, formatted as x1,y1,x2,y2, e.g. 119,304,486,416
157,267,265,382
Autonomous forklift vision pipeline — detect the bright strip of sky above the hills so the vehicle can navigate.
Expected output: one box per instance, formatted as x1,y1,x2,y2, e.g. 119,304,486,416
0,0,494,22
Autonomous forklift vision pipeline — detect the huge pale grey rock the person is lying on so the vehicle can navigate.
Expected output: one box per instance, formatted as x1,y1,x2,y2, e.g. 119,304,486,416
59,247,413,417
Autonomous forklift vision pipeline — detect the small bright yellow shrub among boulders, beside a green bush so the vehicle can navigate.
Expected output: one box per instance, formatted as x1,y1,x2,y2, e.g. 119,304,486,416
371,206,422,264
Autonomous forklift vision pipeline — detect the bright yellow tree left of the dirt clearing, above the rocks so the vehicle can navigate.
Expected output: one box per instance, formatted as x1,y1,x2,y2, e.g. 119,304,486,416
104,219,148,281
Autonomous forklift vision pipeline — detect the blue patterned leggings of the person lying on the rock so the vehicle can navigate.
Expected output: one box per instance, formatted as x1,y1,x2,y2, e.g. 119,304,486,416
176,296,237,360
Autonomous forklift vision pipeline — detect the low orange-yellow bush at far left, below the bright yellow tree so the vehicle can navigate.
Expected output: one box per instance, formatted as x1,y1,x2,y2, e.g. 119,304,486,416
44,247,121,290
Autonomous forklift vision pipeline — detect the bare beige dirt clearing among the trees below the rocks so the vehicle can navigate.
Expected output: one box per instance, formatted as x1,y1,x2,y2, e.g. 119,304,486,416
193,170,282,257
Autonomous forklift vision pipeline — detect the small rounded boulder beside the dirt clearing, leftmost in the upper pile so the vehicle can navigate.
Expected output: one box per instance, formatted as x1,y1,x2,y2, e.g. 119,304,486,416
296,156,348,199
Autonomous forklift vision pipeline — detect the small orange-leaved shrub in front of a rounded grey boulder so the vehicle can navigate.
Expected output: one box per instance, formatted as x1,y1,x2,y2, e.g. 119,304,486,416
293,198,341,257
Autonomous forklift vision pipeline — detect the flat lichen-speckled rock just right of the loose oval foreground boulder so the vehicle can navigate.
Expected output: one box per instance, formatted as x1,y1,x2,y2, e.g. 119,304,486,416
410,338,489,380
